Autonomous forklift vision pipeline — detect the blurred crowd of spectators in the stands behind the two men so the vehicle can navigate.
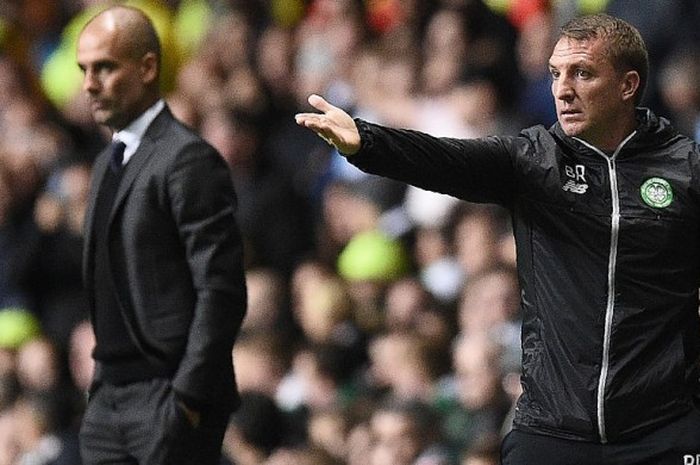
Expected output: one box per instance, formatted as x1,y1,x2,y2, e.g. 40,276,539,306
0,0,700,465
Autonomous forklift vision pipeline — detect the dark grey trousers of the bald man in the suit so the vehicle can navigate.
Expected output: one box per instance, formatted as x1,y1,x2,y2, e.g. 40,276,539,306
80,378,229,465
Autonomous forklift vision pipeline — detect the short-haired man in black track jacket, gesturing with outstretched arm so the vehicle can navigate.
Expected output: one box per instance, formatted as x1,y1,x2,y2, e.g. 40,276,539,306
296,14,700,465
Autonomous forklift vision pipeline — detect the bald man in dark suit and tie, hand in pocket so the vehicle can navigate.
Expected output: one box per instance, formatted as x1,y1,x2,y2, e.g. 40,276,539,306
77,6,246,465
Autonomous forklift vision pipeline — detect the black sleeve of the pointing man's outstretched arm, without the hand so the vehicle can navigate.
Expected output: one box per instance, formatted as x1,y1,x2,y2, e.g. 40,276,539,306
348,119,516,205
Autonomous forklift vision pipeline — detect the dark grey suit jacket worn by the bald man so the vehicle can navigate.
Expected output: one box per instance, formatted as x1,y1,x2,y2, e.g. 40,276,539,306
83,106,246,408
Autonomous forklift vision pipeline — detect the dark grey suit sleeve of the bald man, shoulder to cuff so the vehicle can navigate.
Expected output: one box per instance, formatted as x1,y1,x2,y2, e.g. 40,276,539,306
168,144,246,404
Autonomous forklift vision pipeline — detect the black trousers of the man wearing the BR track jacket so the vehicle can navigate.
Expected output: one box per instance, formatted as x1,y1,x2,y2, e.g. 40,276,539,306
501,410,700,465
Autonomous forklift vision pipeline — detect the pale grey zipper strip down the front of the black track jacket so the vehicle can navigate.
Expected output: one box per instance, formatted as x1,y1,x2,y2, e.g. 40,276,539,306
574,131,637,444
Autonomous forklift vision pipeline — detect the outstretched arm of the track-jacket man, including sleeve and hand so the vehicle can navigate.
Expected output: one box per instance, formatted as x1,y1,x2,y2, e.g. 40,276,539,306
296,95,529,205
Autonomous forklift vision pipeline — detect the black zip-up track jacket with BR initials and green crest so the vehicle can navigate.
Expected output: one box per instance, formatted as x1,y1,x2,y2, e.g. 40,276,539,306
349,109,700,442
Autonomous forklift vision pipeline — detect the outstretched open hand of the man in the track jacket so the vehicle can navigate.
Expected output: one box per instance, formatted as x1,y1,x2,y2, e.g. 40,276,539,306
295,94,360,155
